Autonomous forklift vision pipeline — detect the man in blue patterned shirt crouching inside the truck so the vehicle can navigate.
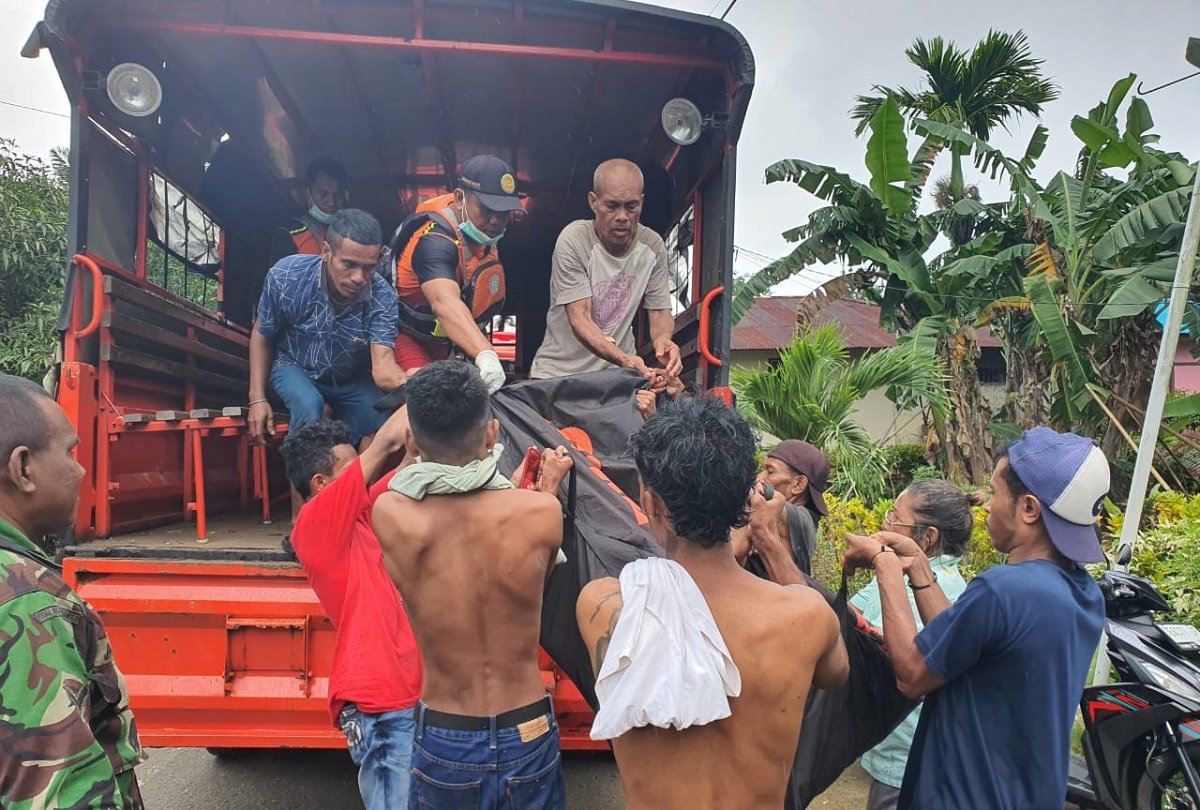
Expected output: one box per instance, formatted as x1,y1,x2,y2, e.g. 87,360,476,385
248,209,404,444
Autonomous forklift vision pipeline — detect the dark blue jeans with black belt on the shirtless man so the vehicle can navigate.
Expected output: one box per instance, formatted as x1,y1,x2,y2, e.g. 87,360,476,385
408,703,566,810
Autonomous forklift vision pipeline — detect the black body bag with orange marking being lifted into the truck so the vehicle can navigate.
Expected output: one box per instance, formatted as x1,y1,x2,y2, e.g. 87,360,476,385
492,370,913,809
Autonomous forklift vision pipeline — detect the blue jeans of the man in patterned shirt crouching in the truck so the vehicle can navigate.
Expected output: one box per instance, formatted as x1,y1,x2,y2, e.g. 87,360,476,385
270,362,388,445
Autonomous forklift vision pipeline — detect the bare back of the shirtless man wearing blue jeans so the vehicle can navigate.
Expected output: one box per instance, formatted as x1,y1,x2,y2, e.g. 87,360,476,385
373,490,563,716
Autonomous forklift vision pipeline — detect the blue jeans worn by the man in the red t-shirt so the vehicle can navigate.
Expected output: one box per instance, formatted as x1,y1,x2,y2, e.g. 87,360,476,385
337,703,413,810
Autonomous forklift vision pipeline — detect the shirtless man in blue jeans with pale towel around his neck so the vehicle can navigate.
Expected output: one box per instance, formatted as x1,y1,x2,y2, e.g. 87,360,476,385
373,360,570,810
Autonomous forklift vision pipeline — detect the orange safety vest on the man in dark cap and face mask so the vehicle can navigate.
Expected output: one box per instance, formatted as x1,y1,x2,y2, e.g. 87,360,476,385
391,193,504,342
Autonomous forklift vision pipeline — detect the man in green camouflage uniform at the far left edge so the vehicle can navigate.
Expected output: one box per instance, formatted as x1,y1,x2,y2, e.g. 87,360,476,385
0,374,145,810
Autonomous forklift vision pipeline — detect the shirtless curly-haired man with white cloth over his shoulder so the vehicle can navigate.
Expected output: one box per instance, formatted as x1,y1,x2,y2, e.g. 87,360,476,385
577,396,850,810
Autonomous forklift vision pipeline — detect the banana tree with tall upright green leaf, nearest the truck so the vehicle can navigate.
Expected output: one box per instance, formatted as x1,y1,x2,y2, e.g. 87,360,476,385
734,100,1045,482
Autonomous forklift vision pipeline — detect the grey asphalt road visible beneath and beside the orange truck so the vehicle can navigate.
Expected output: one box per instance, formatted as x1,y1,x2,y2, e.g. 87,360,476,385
138,748,868,810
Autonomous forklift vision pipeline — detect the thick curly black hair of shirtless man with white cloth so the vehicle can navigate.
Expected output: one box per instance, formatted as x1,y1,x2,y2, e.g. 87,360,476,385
630,395,757,548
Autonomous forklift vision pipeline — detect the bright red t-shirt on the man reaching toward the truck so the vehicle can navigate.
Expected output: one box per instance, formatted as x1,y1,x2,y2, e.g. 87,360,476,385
292,460,421,726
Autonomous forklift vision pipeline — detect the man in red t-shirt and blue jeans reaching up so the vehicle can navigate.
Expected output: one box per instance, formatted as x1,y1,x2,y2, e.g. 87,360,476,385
282,408,421,810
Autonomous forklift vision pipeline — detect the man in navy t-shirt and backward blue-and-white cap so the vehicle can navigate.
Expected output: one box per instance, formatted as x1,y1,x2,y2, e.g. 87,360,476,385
846,427,1109,810
